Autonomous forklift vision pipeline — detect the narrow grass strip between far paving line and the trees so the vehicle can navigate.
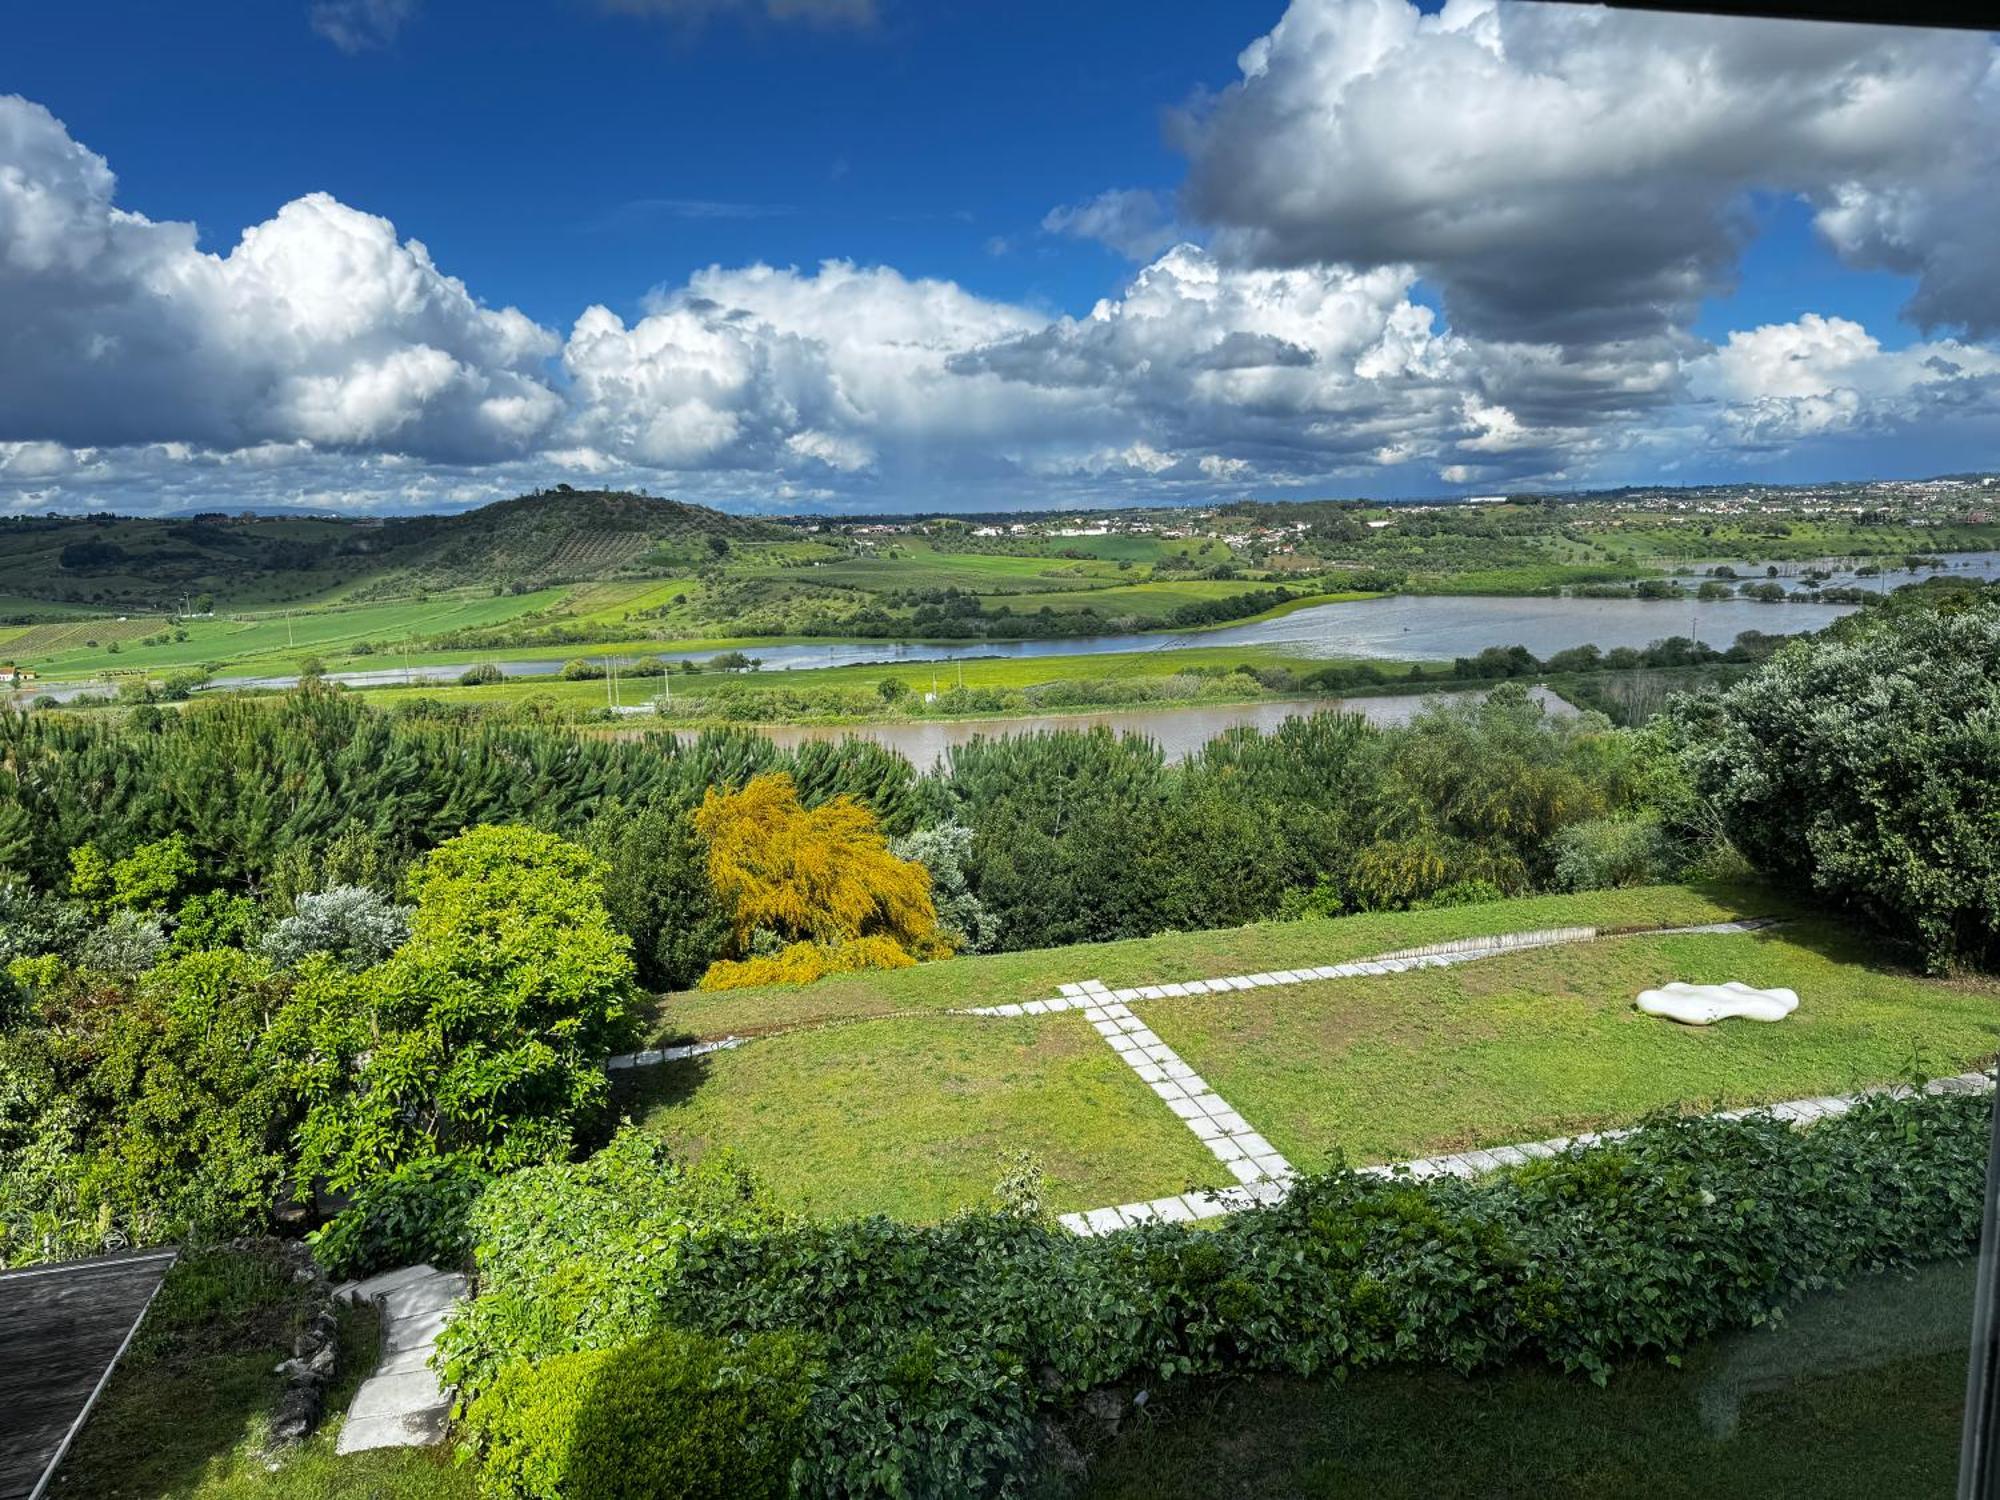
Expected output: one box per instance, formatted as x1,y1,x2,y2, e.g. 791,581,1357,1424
654,886,1796,1042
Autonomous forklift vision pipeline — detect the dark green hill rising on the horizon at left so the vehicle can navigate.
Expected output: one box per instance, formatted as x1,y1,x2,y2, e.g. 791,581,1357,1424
0,488,784,624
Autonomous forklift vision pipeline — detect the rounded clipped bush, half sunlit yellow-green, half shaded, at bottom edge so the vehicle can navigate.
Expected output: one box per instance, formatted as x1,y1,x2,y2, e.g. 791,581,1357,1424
466,1332,808,1500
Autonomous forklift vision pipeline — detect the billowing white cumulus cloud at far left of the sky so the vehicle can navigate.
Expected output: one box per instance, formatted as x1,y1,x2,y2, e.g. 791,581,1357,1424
0,96,562,458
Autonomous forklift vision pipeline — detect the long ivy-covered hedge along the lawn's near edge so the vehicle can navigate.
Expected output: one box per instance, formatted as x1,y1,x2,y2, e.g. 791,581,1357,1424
444,1096,1992,1500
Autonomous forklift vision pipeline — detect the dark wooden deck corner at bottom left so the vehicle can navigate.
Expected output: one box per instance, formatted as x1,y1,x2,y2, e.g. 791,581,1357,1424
0,1250,176,1500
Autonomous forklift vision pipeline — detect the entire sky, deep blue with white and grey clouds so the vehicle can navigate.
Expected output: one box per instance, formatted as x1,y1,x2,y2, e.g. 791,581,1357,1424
0,0,2000,510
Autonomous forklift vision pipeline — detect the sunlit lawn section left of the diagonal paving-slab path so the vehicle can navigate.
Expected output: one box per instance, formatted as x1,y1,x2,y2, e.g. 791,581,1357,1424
620,1014,1226,1220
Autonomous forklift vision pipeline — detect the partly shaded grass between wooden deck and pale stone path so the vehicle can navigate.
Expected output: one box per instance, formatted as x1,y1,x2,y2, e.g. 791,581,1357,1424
54,1248,474,1500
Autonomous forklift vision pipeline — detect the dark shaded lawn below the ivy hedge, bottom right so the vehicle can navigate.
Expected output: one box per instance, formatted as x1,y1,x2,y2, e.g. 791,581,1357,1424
1072,1266,1972,1500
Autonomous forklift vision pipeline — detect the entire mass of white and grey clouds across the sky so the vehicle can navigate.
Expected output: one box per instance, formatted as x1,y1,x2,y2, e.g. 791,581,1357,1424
0,0,2000,512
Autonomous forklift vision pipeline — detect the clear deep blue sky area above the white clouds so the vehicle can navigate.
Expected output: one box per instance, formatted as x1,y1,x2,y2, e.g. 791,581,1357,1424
0,0,1284,324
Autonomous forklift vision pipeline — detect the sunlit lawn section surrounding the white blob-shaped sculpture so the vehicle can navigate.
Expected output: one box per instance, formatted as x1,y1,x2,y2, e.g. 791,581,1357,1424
1134,918,2000,1168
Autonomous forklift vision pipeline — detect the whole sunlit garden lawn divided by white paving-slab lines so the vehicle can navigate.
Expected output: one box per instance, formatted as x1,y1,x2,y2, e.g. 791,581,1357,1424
620,886,2000,1218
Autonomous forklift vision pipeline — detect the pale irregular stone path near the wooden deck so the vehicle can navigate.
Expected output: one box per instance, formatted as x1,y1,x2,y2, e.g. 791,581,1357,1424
334,1266,466,1454
